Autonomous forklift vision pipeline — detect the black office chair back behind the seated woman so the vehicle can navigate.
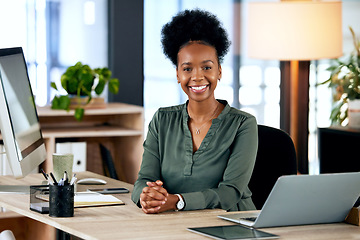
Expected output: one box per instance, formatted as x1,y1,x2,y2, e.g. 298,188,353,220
249,125,297,210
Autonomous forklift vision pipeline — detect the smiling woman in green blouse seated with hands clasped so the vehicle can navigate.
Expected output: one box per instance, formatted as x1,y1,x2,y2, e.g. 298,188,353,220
132,9,257,213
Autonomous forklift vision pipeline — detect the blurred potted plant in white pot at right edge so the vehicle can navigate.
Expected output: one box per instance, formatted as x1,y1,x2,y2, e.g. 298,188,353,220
322,27,360,128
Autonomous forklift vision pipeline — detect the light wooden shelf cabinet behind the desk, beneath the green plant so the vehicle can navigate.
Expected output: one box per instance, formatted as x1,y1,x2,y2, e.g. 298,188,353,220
37,103,144,183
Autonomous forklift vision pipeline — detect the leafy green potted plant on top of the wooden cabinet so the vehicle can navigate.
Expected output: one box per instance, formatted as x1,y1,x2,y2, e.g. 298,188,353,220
51,62,119,121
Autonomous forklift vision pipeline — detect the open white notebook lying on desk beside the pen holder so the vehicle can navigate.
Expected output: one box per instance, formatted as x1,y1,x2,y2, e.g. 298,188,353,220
74,192,125,207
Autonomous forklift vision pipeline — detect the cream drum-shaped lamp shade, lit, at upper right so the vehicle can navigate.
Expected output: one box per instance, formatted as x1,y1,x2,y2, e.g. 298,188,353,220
248,1,342,60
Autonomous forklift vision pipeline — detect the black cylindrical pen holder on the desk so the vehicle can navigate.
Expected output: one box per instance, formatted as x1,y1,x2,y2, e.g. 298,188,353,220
49,185,74,217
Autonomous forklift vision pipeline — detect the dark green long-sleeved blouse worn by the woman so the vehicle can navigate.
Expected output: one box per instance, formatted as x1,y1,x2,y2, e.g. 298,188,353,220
132,100,258,211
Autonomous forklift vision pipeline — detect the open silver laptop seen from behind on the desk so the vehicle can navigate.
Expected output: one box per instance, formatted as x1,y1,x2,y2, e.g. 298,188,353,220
218,172,360,228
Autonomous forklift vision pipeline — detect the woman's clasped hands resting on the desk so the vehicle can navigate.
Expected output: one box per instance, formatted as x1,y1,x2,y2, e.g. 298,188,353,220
140,180,178,213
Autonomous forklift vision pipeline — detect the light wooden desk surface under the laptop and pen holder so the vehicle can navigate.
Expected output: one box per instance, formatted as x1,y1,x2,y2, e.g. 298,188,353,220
0,172,360,240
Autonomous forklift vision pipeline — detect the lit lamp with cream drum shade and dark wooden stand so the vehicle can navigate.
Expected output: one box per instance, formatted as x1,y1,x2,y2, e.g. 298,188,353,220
247,0,342,173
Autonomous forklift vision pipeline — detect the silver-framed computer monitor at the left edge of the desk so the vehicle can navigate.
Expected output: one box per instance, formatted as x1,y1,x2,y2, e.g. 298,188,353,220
0,47,46,178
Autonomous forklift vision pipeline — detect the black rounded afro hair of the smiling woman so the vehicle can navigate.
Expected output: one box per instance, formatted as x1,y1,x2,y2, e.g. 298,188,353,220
161,9,231,66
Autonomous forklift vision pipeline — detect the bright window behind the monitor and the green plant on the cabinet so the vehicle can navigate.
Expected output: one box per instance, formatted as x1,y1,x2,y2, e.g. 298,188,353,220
0,0,108,106
